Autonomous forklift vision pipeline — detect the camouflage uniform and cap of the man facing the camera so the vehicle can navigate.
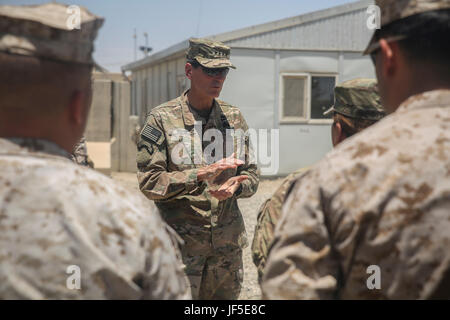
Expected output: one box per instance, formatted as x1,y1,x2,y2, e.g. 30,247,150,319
137,40,259,299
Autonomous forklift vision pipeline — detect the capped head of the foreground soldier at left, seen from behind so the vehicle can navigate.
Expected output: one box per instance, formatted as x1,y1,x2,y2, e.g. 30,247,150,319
0,3,103,152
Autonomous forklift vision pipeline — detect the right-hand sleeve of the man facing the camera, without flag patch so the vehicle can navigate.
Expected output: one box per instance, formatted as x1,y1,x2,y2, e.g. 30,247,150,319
236,112,260,199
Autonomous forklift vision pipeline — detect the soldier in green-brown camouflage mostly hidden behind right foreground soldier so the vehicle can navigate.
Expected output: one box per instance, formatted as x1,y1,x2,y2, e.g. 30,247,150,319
252,79,385,282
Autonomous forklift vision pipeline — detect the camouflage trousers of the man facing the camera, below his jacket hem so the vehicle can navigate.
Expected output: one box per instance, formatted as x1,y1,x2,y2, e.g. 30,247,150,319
182,249,244,300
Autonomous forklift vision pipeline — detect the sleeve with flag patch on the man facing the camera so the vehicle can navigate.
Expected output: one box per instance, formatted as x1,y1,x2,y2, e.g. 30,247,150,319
136,113,198,200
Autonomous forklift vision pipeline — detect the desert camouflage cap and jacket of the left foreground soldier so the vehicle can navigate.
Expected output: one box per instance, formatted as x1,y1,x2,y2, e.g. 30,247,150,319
0,3,191,299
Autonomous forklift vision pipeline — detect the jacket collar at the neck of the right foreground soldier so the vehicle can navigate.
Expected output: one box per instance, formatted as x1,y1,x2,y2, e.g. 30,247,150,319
396,89,450,112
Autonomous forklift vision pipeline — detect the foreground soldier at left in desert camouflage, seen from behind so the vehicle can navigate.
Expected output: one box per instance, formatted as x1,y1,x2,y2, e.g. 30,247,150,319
0,3,191,299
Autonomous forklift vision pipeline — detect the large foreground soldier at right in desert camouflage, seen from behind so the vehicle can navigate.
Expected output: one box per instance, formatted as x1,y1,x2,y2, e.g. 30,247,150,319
262,0,450,299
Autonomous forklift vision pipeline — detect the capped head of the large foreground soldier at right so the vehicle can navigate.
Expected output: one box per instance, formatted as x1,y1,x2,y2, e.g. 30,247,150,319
365,0,450,113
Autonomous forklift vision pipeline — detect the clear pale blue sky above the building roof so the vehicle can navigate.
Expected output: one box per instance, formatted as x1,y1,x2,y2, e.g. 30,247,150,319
0,0,355,72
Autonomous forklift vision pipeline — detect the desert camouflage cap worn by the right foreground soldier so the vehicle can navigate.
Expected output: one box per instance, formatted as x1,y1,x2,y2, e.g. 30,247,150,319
364,0,450,55
